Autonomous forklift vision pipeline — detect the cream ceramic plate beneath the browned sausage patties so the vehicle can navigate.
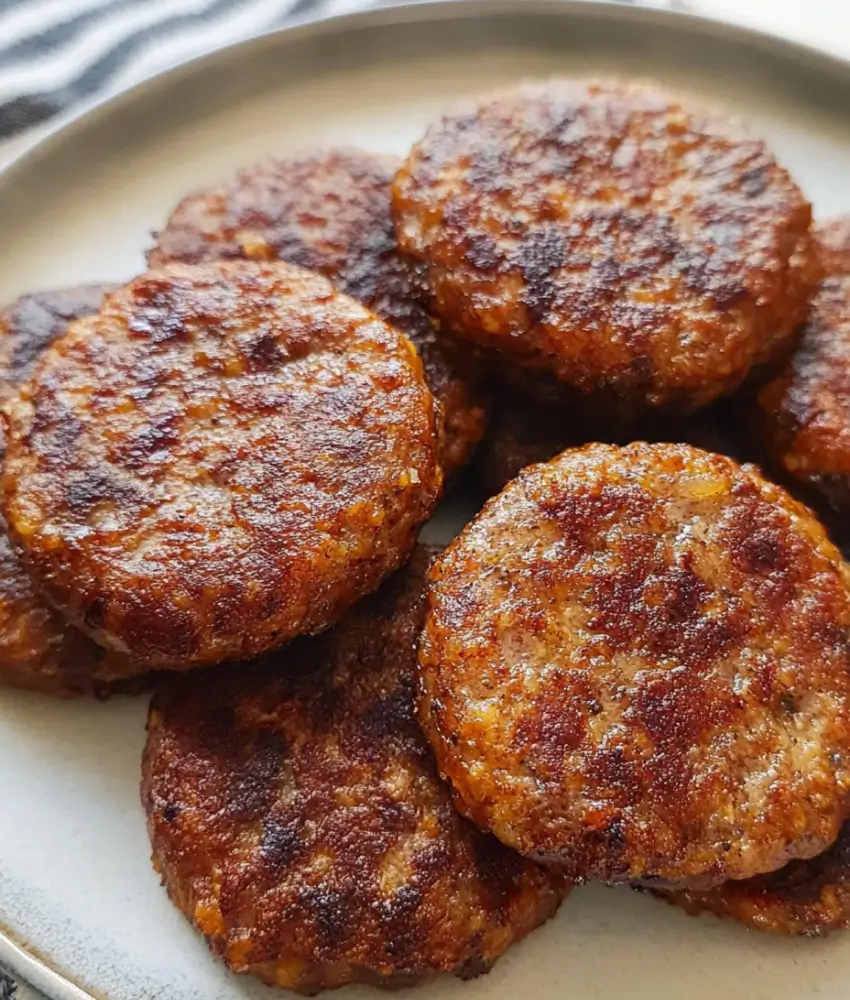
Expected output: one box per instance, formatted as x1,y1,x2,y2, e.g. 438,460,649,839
0,0,850,1000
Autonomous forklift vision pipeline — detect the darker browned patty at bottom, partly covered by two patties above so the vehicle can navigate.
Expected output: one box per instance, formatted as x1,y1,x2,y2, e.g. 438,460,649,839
142,549,568,993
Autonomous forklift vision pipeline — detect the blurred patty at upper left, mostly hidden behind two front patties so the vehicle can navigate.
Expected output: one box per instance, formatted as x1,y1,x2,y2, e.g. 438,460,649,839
148,149,487,475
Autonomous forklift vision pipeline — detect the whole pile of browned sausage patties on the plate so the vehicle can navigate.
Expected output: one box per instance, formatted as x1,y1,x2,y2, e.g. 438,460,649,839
0,81,850,992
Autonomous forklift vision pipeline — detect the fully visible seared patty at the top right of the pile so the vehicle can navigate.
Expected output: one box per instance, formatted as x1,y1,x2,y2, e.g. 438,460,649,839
393,80,819,410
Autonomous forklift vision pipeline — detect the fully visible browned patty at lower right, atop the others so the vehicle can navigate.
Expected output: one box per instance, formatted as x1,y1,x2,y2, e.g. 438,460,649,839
420,443,850,887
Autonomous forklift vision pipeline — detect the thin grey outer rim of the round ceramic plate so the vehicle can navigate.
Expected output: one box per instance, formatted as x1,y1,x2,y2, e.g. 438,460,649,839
0,0,850,1000
